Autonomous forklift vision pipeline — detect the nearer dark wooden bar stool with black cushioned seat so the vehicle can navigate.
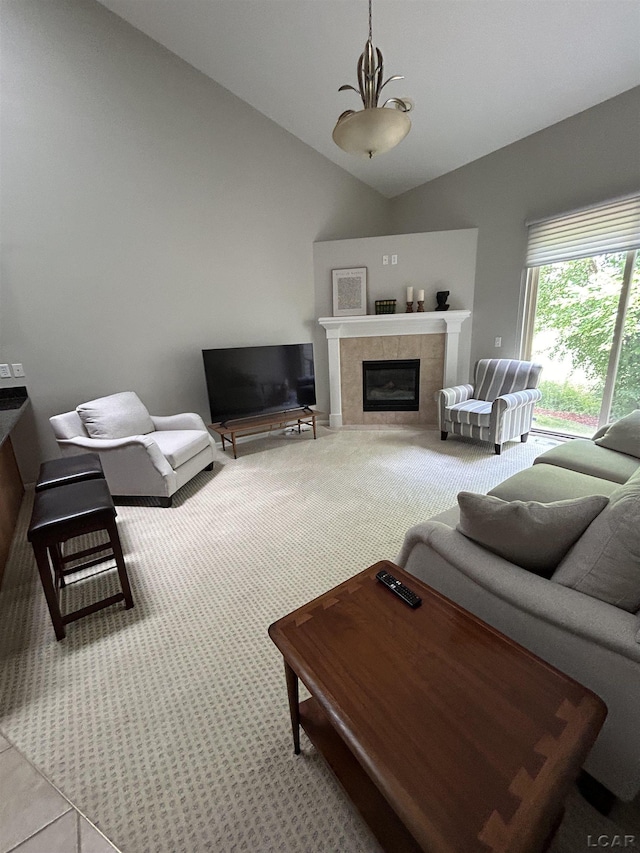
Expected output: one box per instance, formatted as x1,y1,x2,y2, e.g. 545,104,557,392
27,479,133,640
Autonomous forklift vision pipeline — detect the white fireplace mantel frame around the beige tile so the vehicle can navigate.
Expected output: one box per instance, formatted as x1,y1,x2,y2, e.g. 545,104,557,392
318,311,471,427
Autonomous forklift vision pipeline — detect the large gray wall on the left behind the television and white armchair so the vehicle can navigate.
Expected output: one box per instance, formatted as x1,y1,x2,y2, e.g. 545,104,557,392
0,0,390,480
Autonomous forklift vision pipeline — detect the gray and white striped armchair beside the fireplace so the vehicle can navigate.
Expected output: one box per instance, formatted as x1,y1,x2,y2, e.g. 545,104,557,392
438,358,542,453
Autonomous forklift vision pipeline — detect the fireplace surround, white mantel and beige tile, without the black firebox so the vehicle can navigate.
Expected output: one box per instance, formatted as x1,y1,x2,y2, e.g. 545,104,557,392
318,311,471,427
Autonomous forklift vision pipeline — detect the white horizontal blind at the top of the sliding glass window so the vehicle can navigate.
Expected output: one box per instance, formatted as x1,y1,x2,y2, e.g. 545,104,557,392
526,195,640,267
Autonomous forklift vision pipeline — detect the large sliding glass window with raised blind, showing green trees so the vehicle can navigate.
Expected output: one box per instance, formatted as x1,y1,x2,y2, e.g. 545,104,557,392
522,195,640,435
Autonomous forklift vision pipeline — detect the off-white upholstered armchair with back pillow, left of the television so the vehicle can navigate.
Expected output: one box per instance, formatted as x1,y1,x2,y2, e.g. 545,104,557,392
49,391,216,506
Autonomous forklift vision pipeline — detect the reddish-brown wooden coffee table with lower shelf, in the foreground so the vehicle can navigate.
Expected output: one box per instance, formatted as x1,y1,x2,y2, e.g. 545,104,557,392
269,561,606,853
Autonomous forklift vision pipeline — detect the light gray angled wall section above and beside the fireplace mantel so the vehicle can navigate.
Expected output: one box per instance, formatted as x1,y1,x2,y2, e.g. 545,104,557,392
313,228,478,412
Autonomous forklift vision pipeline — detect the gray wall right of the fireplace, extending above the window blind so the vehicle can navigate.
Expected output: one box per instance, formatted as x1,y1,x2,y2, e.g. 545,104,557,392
392,87,640,372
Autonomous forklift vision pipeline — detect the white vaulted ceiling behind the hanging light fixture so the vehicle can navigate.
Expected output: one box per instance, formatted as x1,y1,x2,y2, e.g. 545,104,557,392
100,0,640,197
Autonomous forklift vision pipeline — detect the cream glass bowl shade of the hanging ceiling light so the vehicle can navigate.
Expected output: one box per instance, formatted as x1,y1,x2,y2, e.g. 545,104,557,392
333,107,411,159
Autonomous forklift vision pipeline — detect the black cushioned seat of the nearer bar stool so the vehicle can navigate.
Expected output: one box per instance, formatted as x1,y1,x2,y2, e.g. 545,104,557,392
27,480,116,542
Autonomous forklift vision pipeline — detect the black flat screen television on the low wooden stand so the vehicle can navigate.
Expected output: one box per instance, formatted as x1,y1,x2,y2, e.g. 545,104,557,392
202,344,316,424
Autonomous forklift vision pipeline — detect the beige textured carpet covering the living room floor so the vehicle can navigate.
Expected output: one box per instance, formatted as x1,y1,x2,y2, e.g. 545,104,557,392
0,428,636,853
